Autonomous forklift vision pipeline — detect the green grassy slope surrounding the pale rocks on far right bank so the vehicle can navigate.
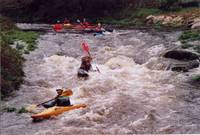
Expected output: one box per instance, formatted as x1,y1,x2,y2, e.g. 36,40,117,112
99,8,200,29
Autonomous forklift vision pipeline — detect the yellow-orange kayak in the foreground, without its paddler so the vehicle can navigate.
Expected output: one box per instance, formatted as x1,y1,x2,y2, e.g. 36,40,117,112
31,104,86,119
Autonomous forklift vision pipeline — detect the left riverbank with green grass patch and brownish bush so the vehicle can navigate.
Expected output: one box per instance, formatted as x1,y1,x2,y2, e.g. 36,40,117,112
0,17,39,98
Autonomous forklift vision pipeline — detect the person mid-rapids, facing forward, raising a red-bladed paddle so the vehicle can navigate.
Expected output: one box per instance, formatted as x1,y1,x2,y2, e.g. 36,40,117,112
77,56,92,79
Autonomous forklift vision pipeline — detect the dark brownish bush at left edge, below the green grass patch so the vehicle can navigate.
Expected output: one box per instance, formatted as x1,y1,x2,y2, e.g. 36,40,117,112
1,42,24,96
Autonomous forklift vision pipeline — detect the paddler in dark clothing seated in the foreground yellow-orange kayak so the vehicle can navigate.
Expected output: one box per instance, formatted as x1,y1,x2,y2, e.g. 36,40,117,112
43,89,73,108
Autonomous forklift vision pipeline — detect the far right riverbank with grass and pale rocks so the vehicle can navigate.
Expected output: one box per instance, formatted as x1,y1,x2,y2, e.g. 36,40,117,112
99,8,200,30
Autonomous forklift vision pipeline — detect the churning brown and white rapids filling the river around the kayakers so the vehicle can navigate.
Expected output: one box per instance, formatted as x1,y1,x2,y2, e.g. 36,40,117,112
0,23,200,135
